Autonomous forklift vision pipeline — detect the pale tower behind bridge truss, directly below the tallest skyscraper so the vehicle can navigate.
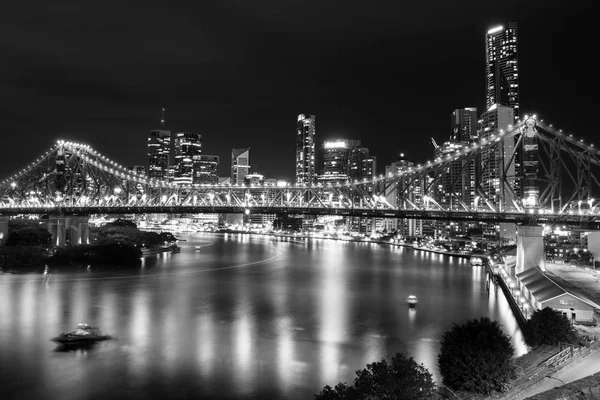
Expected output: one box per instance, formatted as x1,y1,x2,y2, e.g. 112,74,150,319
479,104,520,210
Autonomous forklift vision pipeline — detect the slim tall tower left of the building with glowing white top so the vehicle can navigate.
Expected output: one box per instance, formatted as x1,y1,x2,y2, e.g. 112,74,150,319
296,114,317,185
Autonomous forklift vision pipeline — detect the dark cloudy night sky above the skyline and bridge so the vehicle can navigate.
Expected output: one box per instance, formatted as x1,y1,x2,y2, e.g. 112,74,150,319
0,0,600,179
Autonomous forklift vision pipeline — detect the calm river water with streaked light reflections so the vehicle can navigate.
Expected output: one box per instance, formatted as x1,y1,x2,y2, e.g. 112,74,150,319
0,234,527,400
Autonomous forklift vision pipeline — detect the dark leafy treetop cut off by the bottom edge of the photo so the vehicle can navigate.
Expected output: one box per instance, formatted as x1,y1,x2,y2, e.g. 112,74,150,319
315,353,435,400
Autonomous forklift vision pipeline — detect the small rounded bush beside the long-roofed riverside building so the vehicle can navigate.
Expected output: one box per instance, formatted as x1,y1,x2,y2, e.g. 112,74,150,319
525,307,577,347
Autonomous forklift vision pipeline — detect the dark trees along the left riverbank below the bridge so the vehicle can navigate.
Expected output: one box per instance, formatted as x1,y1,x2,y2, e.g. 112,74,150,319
0,219,177,271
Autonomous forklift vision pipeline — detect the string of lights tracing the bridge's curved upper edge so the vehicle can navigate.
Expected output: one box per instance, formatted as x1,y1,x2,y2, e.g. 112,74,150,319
0,114,600,189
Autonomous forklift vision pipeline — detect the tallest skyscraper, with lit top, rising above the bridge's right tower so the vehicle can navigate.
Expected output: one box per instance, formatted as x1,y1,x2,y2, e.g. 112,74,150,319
485,22,519,117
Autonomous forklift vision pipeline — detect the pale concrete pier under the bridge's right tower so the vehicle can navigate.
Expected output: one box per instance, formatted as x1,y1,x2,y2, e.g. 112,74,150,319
515,225,546,274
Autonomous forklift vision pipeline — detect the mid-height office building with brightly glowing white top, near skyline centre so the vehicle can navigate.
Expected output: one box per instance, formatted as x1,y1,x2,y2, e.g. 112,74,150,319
318,139,360,184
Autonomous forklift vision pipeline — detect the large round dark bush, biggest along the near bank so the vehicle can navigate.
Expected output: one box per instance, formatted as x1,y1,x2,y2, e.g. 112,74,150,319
438,317,516,394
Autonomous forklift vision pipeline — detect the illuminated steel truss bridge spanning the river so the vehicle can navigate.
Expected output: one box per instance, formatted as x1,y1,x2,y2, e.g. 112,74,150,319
0,116,600,227
